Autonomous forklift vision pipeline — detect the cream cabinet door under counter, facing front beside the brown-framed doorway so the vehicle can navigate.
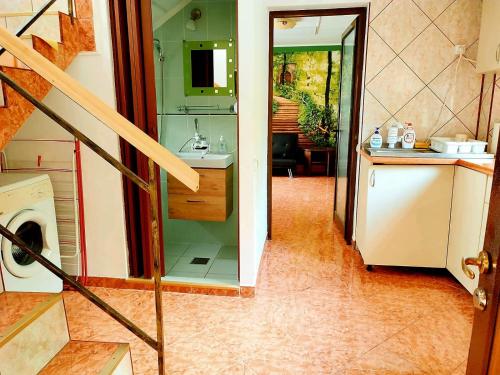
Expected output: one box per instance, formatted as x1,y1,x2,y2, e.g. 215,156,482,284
360,165,454,268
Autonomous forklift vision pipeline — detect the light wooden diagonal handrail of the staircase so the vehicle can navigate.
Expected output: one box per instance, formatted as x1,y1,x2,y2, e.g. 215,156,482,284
0,27,199,191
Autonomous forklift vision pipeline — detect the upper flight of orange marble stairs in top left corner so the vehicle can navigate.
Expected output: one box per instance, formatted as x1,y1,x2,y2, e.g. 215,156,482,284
0,0,95,150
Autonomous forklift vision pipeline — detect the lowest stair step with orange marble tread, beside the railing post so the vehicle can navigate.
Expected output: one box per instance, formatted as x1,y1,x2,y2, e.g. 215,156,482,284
39,340,133,375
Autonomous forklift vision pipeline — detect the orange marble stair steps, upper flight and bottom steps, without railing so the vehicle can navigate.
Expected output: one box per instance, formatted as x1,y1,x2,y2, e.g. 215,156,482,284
0,0,133,375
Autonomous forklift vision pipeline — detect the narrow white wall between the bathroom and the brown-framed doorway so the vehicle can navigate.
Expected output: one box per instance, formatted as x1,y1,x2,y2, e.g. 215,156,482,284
238,0,368,286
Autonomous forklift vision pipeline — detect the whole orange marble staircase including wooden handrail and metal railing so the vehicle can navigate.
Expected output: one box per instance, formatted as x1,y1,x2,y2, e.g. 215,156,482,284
0,0,200,375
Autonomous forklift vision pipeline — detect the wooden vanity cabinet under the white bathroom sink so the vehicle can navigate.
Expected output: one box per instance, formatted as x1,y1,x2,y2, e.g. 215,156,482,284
167,164,233,222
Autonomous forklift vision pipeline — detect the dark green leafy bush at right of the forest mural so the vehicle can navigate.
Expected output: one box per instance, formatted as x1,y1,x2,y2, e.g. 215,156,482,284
298,93,337,147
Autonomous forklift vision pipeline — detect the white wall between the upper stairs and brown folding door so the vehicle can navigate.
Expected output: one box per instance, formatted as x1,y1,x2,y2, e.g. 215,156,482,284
16,0,128,278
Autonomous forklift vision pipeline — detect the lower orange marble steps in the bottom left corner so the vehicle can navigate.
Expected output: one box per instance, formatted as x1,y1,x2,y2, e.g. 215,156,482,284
0,292,133,375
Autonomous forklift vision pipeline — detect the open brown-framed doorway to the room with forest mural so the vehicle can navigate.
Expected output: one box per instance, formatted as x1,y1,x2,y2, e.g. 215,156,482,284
268,8,366,244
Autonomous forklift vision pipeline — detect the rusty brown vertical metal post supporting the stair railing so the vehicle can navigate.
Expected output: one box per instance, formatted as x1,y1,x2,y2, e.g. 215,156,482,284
148,159,165,375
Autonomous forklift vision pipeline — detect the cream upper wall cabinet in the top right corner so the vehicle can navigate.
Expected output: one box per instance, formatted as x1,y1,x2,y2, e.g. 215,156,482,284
477,0,500,73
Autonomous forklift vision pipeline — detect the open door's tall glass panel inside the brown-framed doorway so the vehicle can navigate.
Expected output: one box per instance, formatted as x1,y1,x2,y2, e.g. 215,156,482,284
334,22,356,229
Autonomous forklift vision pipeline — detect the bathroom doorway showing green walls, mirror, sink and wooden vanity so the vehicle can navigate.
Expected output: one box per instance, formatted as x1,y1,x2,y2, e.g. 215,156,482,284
151,0,239,288
